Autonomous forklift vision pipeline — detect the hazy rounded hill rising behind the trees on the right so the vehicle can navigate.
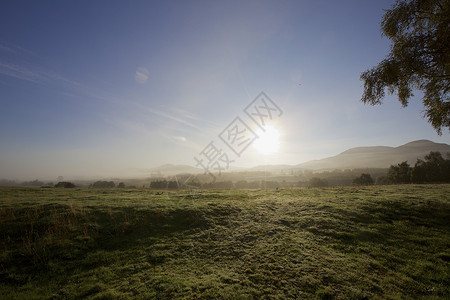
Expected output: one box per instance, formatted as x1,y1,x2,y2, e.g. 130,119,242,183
295,140,450,170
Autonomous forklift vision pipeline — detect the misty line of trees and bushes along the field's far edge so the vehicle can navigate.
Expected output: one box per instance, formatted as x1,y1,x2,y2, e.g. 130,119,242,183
0,151,450,190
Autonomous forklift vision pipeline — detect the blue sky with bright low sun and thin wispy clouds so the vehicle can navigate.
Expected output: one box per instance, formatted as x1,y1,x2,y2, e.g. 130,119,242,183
0,0,450,180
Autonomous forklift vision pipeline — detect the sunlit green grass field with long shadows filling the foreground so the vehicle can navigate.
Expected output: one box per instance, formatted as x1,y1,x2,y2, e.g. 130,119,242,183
0,185,450,299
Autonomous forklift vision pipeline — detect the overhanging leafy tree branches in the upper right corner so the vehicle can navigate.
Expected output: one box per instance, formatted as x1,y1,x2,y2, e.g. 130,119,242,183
361,0,450,134
